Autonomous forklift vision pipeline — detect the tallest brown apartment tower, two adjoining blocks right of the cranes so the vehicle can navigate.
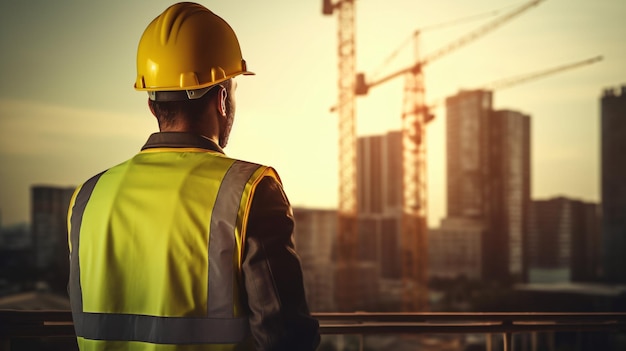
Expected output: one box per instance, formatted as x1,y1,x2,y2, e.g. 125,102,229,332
446,90,530,282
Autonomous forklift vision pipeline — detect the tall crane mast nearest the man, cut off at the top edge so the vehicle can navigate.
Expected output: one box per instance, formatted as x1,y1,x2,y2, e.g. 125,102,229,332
322,0,358,311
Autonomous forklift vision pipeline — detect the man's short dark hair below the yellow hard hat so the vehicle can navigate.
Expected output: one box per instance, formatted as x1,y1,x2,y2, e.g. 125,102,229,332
148,79,232,127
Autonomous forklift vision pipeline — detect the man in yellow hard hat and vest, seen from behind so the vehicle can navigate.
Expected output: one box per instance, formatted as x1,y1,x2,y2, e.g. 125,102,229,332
68,3,320,351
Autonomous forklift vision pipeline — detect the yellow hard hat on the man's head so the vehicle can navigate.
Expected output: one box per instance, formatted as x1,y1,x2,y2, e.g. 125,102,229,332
135,2,254,98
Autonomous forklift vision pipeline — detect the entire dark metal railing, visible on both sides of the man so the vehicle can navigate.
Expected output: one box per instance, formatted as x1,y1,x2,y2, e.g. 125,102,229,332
0,310,626,351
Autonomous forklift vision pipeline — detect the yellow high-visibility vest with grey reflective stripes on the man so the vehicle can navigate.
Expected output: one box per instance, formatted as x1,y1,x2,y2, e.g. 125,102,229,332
68,144,279,351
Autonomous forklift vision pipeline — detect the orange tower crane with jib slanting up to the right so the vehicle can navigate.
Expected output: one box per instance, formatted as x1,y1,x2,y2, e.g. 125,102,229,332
356,0,545,311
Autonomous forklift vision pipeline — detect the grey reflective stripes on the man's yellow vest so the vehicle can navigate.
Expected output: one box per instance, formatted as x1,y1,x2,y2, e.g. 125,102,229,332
69,161,264,344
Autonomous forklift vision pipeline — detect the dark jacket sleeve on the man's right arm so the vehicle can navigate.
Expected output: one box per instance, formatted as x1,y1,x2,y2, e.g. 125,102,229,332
242,177,320,351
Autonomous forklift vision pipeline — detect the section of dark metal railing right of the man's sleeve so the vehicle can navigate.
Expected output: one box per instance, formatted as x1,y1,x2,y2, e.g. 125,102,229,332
316,312,626,351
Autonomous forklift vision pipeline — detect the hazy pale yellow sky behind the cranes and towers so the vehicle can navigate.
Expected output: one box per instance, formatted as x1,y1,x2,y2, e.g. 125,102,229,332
0,0,626,226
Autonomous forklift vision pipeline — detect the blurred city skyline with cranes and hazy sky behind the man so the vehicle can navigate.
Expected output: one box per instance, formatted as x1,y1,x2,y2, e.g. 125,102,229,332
0,0,626,350
